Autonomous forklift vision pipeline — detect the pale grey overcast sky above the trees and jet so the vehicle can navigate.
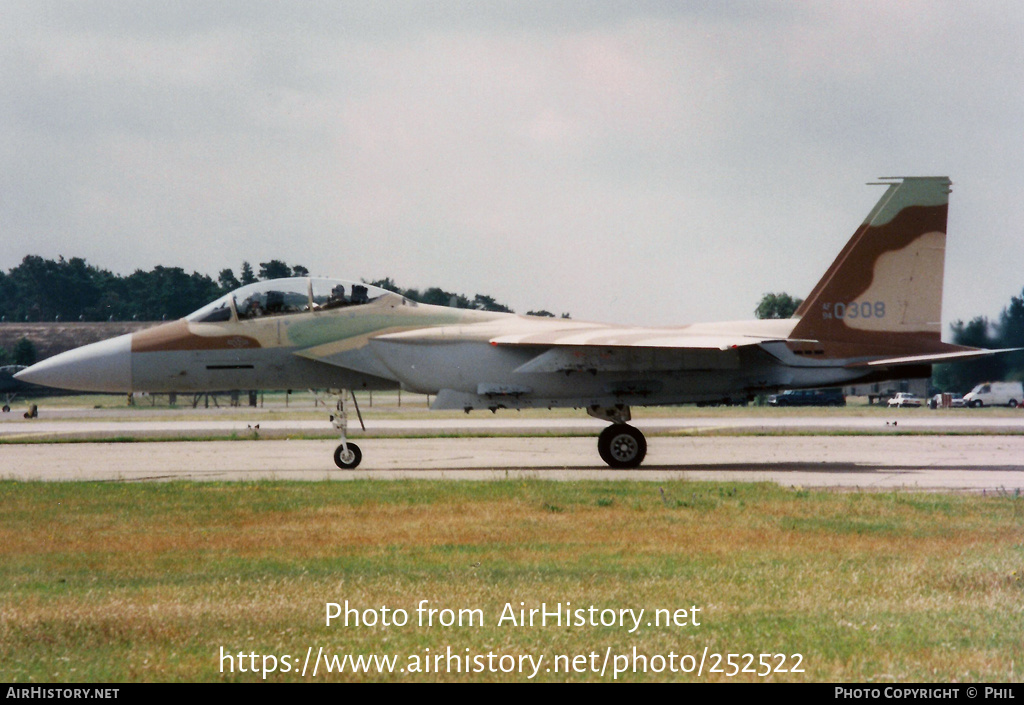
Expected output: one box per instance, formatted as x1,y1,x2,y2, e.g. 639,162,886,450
0,0,1024,327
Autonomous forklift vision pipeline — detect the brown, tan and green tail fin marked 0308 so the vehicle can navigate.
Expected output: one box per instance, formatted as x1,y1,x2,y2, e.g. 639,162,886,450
791,176,951,353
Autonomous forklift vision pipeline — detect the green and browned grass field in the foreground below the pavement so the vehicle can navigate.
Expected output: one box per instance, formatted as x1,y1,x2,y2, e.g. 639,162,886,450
0,481,1024,681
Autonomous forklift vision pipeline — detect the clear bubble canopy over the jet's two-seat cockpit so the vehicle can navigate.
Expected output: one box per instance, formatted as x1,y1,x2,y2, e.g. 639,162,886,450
185,277,397,323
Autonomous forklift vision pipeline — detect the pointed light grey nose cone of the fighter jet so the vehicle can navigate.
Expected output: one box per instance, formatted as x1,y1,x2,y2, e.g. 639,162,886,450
14,333,132,391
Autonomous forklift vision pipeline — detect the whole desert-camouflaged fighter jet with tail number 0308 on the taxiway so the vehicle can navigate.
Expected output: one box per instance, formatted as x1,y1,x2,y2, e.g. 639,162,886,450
16,176,1007,468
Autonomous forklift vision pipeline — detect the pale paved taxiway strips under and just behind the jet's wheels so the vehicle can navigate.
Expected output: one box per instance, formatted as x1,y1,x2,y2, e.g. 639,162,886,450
0,415,1024,493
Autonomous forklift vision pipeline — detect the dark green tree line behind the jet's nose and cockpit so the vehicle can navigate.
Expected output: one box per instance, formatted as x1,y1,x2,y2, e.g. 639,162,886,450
0,255,544,322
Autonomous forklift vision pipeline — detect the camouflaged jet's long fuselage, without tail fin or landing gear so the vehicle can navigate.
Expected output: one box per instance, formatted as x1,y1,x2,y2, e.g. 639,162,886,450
14,279,897,409
